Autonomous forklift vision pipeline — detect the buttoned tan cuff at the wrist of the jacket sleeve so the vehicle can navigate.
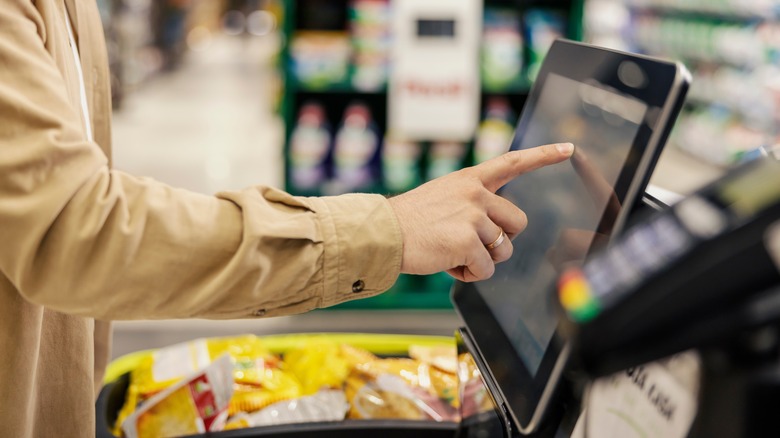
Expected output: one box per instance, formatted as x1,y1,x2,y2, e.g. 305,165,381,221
306,194,403,307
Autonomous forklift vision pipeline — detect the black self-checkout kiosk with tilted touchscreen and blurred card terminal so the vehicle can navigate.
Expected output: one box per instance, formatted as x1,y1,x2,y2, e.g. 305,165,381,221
453,41,780,438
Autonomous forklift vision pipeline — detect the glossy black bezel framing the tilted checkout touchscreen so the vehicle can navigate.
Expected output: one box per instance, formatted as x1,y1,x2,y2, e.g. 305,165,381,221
451,40,688,429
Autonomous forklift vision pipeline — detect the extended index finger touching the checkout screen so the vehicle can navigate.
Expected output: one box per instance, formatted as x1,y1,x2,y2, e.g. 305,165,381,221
475,143,574,193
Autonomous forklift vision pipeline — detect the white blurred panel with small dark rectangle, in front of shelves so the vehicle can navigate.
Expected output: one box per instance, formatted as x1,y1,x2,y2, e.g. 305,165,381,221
388,0,482,141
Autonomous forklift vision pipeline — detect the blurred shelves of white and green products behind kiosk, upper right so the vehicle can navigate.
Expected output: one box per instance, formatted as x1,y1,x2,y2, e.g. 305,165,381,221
584,0,780,166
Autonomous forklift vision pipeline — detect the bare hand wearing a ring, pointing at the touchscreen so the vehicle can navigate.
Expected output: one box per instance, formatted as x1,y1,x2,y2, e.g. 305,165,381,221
390,143,574,282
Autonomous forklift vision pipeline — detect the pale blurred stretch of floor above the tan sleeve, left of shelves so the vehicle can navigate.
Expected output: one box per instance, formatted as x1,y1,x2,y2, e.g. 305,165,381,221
113,33,283,194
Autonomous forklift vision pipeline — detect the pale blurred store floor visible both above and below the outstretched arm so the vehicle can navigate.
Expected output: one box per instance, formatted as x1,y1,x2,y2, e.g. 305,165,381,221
107,37,457,357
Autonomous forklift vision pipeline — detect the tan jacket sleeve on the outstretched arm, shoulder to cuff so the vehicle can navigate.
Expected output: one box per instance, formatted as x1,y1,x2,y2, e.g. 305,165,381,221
0,1,402,319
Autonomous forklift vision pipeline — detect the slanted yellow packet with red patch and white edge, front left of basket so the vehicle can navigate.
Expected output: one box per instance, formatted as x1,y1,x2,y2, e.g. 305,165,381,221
122,355,233,438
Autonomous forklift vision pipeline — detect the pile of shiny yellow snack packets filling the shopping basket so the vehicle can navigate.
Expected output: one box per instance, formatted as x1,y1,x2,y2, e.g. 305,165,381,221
110,335,459,438
